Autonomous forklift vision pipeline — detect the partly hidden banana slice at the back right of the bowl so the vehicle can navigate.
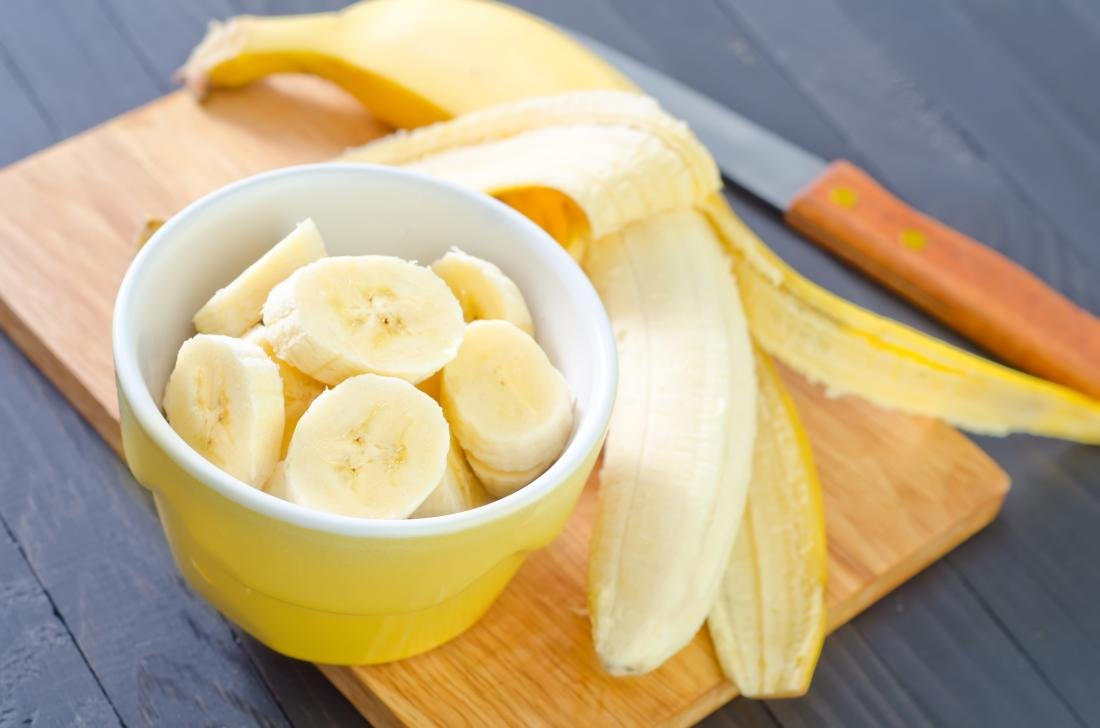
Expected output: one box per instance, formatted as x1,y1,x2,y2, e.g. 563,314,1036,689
431,247,535,337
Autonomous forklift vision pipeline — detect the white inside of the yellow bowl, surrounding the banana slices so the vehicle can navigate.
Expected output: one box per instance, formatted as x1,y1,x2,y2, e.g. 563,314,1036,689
114,164,615,541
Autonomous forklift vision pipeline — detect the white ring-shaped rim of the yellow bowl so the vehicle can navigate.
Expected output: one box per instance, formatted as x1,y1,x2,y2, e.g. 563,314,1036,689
111,162,618,539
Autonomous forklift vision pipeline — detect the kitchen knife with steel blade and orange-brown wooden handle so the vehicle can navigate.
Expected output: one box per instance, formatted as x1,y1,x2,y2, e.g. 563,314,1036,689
576,34,1100,398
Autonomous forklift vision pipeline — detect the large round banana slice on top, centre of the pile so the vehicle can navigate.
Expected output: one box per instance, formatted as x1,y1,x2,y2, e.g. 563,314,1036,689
264,255,465,385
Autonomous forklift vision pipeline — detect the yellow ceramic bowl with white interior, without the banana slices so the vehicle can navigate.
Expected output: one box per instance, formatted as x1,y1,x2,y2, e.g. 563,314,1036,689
113,164,616,664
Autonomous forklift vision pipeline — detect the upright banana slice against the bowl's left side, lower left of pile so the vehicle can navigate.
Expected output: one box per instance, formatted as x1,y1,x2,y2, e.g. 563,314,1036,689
164,333,284,487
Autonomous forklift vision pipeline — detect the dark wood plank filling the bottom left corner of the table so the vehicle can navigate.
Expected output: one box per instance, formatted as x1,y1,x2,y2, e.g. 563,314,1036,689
0,525,119,726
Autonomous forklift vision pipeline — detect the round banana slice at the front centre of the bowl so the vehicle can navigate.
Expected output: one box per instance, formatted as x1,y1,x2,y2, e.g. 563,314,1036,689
285,374,451,518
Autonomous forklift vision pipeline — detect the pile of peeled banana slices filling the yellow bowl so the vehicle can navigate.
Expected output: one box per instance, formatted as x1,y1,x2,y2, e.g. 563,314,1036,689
164,220,573,518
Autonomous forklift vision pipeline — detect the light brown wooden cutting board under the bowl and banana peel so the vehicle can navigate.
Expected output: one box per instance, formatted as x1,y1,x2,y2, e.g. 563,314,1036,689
0,77,1008,725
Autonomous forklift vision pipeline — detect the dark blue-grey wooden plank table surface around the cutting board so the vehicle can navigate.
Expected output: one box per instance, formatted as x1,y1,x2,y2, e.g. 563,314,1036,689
0,0,1100,728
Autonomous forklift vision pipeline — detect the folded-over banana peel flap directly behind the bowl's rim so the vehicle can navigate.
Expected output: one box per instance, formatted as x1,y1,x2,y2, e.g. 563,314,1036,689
343,91,722,260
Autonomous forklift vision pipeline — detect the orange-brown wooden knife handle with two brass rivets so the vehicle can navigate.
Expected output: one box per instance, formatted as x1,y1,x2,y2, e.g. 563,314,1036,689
787,161,1100,399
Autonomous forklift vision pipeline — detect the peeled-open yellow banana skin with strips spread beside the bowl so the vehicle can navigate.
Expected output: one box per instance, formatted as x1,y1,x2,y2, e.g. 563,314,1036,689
182,0,1100,697
